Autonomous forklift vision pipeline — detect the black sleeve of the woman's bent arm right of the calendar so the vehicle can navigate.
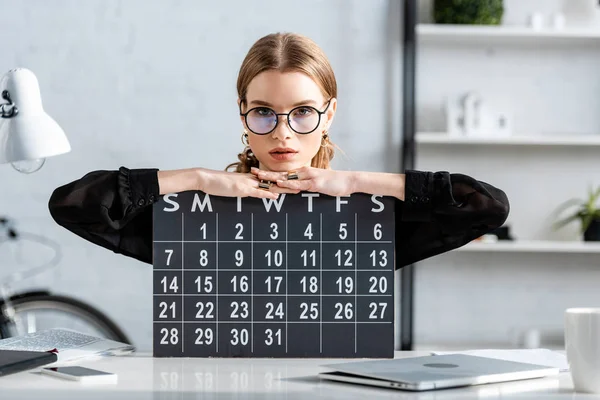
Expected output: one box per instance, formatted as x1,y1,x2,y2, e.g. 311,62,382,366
396,170,510,269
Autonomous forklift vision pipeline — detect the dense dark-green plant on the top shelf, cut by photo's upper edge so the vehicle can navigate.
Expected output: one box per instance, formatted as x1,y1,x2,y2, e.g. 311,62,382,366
433,0,504,25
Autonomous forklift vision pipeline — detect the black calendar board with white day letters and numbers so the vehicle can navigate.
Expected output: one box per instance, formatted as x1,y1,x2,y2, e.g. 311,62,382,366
153,191,395,358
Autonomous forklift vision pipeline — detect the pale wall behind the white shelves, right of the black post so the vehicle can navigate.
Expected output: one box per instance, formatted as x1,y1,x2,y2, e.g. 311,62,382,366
415,0,600,347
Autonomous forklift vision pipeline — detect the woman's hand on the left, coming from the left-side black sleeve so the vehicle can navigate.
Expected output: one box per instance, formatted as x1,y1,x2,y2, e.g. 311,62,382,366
199,169,298,199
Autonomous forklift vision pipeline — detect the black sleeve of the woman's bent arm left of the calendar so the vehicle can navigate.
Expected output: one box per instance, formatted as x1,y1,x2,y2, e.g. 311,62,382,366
48,167,159,263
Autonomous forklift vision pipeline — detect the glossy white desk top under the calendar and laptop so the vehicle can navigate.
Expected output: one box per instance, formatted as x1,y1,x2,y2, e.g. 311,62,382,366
0,352,600,400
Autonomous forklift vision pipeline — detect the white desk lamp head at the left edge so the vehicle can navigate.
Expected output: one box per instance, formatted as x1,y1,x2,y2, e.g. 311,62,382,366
0,68,71,173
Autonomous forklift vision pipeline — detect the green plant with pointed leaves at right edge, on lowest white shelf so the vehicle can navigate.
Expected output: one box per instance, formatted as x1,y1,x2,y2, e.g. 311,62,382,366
555,187,600,242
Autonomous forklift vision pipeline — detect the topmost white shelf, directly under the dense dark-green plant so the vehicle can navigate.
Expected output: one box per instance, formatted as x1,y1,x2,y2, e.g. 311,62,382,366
417,24,600,44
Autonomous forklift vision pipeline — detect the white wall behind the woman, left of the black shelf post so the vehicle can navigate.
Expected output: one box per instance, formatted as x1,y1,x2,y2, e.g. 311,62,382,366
0,0,400,350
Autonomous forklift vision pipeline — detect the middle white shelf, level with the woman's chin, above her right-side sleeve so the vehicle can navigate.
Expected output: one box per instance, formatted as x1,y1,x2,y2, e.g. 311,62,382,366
415,132,600,146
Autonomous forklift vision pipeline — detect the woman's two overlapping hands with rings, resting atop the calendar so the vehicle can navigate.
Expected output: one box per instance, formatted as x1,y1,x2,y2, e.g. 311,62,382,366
200,166,354,199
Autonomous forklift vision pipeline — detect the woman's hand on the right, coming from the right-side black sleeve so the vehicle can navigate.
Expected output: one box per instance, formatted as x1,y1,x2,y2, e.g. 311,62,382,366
251,167,353,196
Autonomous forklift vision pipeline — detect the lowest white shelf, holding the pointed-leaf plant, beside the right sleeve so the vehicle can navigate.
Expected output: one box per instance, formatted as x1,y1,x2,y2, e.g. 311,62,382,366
454,240,600,254
